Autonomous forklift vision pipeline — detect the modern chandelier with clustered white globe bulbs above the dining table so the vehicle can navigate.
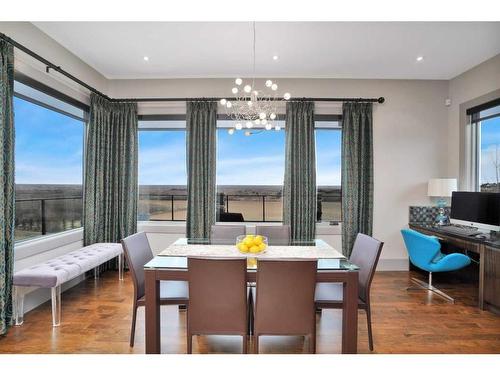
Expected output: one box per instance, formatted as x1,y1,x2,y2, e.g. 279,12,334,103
220,22,291,136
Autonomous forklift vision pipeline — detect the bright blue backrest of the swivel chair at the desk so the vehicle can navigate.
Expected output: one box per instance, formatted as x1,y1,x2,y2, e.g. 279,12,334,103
401,229,441,271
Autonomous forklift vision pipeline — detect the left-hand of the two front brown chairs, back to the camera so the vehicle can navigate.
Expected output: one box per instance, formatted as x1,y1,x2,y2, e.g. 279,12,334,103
187,258,248,354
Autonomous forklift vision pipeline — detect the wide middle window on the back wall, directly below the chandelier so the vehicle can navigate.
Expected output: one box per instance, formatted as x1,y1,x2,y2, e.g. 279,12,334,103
217,120,285,222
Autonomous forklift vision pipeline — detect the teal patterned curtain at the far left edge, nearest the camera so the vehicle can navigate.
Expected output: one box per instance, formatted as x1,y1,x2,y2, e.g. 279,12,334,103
0,40,15,335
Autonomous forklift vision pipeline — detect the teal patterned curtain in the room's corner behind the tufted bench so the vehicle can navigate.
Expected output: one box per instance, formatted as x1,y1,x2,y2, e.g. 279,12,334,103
83,94,138,245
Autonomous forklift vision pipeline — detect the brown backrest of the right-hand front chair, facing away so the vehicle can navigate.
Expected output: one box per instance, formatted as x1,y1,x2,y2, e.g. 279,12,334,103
254,259,317,335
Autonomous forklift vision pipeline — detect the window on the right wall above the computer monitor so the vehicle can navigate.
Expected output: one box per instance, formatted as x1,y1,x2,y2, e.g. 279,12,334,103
472,101,500,192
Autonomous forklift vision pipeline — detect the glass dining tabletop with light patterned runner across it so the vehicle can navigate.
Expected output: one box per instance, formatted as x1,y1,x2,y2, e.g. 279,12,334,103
144,238,359,271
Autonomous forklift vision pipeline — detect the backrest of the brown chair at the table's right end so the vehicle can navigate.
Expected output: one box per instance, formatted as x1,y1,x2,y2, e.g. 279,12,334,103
349,233,384,302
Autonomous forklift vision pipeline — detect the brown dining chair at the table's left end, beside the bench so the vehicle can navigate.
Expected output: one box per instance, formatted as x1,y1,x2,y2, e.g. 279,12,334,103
121,232,189,347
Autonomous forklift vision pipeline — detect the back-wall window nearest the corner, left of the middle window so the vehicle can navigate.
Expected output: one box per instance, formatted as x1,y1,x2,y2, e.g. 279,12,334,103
138,120,187,221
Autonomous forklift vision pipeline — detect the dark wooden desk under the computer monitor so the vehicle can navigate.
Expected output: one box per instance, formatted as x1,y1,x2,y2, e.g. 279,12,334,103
409,223,500,314
